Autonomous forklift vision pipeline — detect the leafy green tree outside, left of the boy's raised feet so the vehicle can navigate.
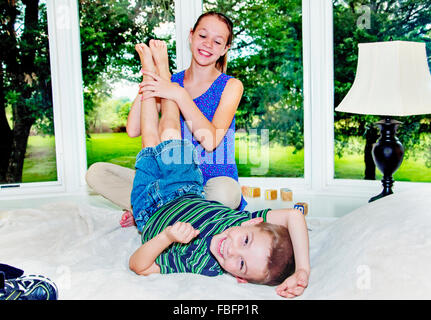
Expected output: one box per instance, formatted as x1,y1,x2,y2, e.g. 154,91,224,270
79,0,175,124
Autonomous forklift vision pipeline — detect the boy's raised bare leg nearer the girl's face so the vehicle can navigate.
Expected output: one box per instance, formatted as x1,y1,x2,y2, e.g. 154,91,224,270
149,39,181,141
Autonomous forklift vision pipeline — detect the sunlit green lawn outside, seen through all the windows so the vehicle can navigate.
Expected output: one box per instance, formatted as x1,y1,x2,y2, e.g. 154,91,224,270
19,133,431,182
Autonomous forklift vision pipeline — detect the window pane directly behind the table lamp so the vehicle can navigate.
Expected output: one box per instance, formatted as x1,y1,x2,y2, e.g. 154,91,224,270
334,0,431,182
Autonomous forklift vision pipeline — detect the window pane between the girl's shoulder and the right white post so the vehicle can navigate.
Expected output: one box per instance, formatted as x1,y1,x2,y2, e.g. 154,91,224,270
203,0,304,177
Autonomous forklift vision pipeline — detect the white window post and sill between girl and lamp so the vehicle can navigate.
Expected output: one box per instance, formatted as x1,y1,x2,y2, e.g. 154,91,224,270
239,0,427,198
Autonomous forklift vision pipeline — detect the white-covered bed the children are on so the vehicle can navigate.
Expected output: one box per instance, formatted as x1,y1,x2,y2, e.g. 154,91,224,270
0,185,431,300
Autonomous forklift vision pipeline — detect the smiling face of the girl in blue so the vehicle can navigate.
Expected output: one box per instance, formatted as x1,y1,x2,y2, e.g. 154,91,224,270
189,16,229,65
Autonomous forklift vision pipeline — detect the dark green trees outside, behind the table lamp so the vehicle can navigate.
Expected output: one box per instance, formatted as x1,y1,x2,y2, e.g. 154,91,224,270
334,0,431,180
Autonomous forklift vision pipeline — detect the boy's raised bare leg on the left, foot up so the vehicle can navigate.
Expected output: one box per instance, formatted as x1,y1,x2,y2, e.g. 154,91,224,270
135,43,160,148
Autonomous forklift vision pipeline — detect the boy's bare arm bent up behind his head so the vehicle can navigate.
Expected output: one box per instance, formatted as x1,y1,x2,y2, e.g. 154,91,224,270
266,209,310,297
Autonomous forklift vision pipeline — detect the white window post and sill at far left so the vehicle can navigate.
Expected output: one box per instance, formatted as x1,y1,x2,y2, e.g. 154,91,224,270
0,0,86,199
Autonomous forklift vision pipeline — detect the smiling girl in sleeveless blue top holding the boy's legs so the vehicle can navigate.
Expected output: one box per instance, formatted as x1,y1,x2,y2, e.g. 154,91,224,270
87,12,247,226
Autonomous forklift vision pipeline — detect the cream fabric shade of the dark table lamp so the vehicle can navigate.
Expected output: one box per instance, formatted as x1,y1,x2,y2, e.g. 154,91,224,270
335,41,431,116
